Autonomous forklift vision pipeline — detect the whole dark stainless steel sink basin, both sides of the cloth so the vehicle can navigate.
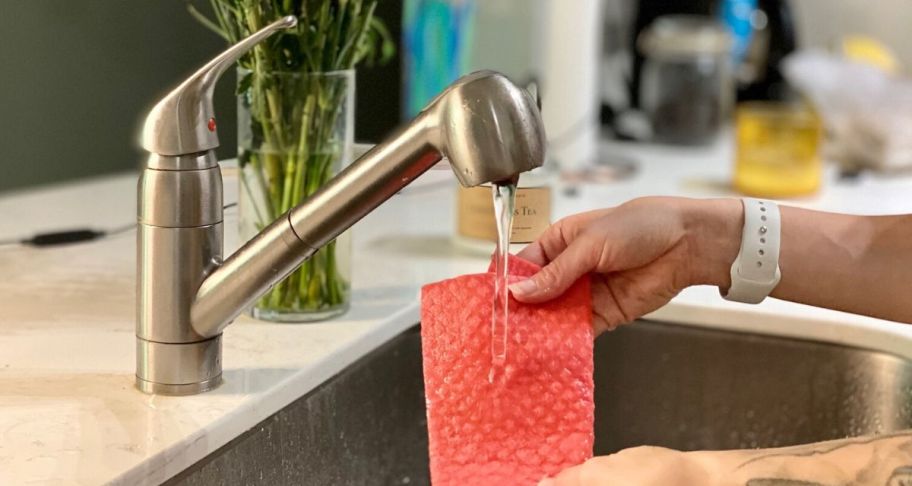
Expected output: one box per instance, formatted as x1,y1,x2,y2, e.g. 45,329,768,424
169,321,912,485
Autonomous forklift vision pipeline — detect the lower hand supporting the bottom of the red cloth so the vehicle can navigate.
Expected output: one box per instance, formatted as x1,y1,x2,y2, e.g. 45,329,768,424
539,446,712,486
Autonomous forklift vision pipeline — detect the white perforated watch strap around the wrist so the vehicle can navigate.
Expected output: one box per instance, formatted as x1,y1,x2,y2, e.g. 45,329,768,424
720,198,781,304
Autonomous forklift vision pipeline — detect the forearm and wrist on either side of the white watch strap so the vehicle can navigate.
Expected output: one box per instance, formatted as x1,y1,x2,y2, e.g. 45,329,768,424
687,199,912,323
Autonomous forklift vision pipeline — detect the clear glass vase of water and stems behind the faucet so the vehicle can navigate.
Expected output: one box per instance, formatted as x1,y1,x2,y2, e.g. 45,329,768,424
238,69,355,322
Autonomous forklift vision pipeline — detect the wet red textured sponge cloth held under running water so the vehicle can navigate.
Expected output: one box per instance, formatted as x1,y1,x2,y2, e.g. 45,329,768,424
421,257,594,486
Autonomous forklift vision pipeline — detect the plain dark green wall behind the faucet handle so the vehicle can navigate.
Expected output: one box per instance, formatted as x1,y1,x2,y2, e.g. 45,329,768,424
0,0,235,191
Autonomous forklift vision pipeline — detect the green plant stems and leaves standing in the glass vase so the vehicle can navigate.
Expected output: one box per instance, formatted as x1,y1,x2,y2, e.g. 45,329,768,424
199,0,392,316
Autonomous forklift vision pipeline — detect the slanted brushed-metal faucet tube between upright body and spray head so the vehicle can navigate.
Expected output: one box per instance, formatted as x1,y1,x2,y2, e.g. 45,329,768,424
190,114,442,337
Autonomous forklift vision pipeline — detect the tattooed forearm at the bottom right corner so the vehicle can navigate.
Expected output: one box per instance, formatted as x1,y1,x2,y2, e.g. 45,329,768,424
687,431,912,486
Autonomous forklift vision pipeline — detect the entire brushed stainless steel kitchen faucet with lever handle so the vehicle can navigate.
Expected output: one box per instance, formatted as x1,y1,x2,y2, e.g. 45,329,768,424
136,17,545,395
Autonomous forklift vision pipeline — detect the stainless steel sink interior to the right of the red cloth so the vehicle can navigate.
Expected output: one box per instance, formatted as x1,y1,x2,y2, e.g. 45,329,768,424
595,322,912,454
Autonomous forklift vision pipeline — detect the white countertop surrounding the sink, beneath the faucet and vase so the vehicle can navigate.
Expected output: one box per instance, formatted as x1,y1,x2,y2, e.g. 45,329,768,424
0,139,912,485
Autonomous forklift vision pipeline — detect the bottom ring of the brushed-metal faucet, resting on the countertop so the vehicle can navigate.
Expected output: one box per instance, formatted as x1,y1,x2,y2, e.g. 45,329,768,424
136,334,222,395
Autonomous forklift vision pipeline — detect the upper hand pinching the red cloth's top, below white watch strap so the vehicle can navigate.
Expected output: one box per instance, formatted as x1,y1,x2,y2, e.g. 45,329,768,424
510,197,743,334
